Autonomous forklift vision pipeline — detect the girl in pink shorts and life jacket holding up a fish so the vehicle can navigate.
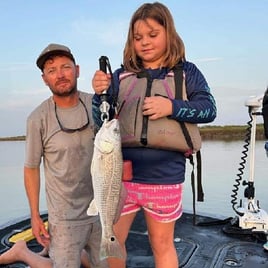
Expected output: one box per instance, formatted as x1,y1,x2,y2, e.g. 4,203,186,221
92,2,216,268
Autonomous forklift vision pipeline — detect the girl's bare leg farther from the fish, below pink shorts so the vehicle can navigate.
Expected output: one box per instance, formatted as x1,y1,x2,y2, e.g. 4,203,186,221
144,211,179,268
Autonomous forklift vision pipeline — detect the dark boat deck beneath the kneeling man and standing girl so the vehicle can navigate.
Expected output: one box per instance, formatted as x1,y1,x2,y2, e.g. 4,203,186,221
0,213,268,268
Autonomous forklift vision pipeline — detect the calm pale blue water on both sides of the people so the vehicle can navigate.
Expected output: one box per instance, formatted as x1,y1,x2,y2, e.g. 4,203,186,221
0,141,268,226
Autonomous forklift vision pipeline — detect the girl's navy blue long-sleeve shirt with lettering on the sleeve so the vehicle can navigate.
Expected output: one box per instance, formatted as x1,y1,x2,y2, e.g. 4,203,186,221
93,62,216,184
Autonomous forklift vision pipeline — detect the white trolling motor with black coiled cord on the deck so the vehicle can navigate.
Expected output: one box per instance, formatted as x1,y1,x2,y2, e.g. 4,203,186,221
232,91,268,250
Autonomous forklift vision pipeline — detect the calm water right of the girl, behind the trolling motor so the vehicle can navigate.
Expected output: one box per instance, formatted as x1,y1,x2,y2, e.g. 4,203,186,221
184,141,268,217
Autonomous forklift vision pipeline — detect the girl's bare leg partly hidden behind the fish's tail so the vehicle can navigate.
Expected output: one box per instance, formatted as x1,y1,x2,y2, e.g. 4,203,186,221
108,212,136,268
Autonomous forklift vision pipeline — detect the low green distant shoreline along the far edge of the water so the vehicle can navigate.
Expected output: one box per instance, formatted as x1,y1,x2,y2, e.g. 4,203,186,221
0,124,265,141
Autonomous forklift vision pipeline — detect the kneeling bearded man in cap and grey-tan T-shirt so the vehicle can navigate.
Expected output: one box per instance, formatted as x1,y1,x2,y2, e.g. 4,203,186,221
24,44,106,268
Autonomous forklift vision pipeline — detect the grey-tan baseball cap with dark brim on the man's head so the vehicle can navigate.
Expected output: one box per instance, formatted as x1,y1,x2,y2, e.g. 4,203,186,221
36,44,75,71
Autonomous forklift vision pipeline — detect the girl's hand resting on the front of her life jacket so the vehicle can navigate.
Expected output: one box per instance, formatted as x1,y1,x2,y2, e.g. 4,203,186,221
143,96,172,120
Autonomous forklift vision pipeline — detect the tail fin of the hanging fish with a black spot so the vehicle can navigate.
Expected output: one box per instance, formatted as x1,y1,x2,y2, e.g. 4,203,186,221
100,236,126,260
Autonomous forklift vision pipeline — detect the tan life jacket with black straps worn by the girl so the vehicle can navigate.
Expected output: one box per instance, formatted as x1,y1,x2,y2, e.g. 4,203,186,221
118,65,201,154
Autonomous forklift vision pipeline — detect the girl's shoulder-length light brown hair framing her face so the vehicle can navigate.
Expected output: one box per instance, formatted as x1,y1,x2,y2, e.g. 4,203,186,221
123,2,185,72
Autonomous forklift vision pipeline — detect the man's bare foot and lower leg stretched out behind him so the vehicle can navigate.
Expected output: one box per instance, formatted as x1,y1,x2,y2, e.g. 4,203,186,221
0,240,52,268
